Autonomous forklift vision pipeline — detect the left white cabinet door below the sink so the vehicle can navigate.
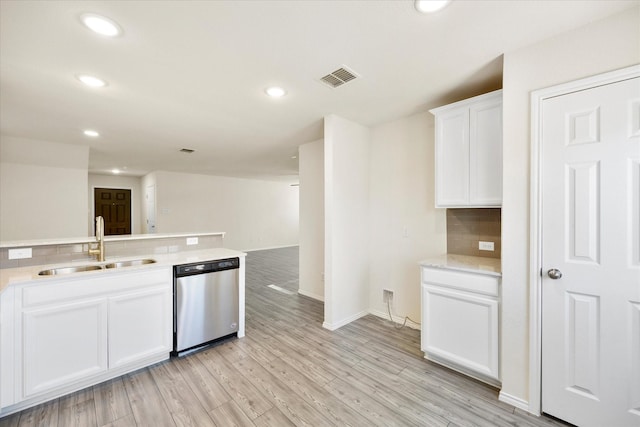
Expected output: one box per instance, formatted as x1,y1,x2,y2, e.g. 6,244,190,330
22,299,107,398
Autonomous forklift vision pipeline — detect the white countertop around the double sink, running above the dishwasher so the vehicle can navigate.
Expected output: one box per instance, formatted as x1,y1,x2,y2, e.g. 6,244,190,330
0,247,247,293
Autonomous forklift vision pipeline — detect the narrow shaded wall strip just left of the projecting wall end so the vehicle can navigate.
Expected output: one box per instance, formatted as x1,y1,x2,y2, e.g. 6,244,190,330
298,139,324,301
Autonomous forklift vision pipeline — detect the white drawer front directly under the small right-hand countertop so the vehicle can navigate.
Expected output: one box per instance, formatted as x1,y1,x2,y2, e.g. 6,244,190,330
422,267,500,297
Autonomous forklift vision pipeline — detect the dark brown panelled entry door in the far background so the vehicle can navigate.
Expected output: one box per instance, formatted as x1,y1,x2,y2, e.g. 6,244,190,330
94,188,131,236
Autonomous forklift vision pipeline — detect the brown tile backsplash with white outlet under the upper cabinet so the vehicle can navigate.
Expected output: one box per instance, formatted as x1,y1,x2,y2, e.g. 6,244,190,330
447,208,502,258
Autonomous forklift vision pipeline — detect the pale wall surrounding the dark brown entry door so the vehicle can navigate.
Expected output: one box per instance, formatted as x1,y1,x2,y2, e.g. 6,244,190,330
88,173,143,235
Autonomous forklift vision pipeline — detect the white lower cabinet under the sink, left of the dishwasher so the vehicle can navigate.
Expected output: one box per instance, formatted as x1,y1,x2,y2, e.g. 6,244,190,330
0,267,173,412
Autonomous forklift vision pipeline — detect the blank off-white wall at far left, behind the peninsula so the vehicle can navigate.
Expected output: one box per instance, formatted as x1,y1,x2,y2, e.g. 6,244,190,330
0,136,89,241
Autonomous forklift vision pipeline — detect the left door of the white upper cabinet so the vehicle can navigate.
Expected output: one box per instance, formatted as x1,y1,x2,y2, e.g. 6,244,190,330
435,107,469,207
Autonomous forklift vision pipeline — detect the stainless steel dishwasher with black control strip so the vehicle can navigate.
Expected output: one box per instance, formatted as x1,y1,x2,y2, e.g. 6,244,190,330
171,258,240,356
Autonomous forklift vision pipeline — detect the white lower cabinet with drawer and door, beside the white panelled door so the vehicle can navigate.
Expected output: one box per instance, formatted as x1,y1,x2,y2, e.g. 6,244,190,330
421,267,500,385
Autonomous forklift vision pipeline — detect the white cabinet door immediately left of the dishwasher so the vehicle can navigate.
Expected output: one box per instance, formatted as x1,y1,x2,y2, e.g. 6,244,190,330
109,284,173,368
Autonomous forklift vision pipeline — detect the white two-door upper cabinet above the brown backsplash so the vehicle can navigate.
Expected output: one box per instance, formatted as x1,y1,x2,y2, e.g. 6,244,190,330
431,90,502,208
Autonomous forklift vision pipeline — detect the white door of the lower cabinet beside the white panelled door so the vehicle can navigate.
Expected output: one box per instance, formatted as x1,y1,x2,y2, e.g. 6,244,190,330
422,284,499,379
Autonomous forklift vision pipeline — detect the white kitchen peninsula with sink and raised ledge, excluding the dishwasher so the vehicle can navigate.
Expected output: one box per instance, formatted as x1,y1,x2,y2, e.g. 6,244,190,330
0,233,246,416
